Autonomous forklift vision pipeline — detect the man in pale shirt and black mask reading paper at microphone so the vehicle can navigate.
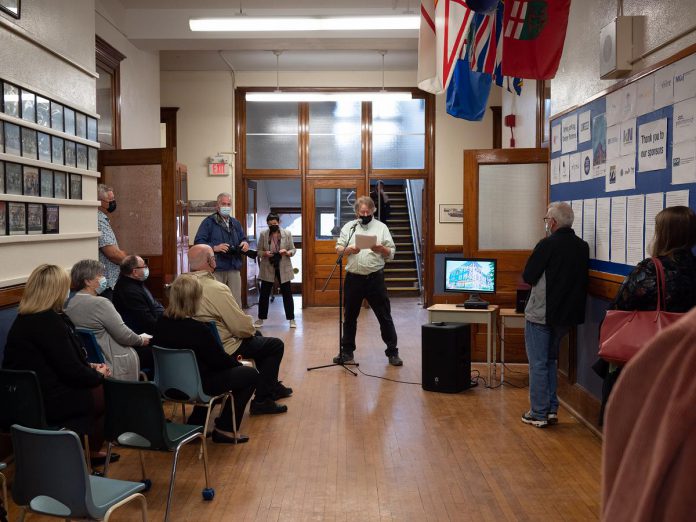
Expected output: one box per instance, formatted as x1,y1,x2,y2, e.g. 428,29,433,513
333,196,403,366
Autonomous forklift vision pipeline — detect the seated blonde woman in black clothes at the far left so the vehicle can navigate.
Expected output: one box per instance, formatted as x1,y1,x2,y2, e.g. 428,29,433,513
3,265,115,464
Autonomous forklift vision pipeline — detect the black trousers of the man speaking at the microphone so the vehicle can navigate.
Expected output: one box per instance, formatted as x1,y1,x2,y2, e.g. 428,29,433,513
341,270,399,357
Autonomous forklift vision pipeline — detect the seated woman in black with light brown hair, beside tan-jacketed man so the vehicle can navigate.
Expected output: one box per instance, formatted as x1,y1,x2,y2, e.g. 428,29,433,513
151,274,259,443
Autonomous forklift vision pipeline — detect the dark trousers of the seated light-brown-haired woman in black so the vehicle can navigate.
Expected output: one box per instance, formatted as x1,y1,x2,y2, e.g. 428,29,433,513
189,366,259,432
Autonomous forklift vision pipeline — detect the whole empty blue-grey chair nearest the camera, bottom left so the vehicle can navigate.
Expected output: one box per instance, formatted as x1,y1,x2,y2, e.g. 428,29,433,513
12,424,147,521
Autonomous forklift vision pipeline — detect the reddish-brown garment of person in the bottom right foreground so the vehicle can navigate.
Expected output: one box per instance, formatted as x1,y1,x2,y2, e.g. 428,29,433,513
601,304,696,522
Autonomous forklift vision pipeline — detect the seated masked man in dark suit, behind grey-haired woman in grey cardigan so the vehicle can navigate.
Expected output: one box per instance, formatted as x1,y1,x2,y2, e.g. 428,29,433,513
113,255,164,334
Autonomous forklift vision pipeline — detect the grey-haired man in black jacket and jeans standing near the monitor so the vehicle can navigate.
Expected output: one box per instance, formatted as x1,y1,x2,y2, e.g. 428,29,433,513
522,202,590,428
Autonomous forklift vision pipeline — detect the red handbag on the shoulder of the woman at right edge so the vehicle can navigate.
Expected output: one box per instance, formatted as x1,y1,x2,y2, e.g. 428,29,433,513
599,257,684,364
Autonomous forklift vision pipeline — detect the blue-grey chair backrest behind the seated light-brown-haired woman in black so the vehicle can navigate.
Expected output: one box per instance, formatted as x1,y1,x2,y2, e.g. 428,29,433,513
152,346,210,403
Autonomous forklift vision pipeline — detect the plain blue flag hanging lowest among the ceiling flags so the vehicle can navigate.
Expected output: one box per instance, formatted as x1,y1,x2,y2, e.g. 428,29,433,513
447,60,493,121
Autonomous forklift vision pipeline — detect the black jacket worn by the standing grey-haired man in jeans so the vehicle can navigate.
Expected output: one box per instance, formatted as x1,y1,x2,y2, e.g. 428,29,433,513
522,227,590,326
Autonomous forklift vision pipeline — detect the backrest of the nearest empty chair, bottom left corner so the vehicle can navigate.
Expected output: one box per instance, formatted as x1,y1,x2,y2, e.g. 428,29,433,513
12,424,97,518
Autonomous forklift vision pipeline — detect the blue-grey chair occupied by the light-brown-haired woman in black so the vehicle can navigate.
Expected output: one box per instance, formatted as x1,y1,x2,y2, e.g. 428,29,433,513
152,346,237,441
